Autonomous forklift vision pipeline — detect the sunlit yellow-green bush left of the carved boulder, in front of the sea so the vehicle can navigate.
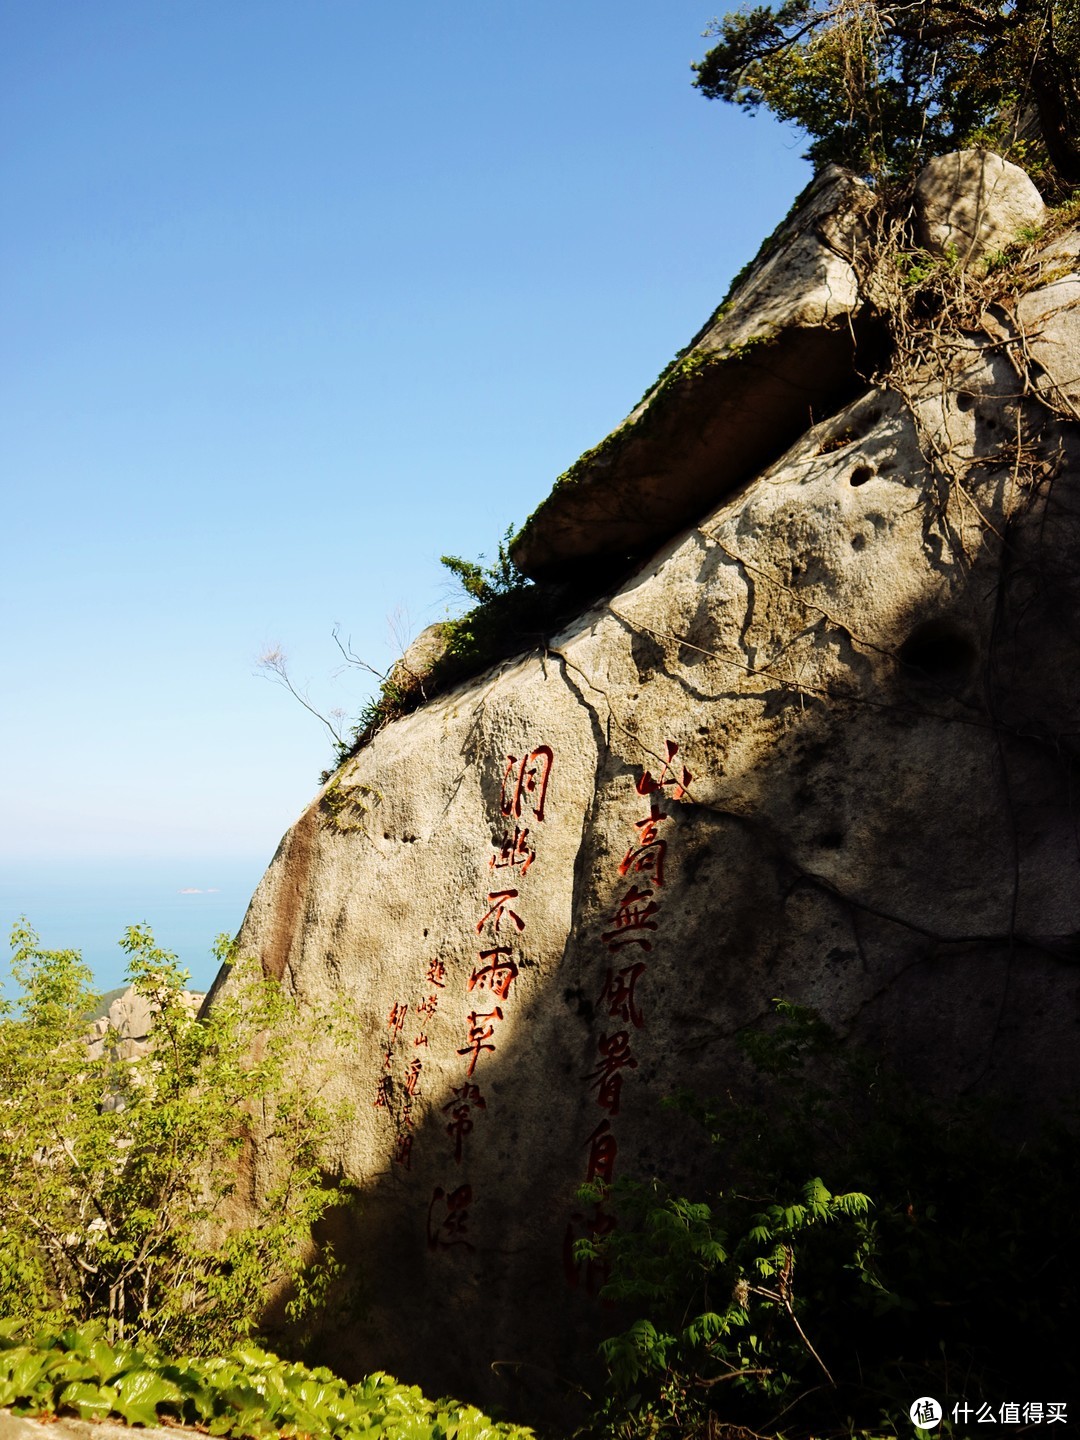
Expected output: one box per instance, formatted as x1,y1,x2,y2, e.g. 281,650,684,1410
0,922,360,1351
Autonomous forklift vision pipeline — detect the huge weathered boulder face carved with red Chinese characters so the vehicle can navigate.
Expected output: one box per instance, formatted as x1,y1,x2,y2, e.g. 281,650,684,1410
217,160,1080,1417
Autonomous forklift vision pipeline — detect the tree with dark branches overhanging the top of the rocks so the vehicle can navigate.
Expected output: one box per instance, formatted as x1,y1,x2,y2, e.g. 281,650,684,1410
694,0,1080,186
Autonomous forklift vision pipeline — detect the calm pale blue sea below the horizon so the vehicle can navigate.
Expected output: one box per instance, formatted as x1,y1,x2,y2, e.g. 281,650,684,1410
0,855,269,998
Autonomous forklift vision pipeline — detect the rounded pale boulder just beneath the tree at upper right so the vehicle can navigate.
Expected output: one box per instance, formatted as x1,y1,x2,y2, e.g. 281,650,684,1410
914,150,1047,265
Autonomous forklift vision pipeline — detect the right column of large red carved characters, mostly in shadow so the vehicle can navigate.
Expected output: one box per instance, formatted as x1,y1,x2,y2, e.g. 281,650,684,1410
563,740,693,1295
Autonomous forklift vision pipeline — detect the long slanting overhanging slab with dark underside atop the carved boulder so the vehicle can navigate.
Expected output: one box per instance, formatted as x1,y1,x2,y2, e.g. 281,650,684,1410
513,166,874,579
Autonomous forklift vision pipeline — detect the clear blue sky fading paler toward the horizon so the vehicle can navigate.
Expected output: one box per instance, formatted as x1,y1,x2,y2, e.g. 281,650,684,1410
0,0,809,979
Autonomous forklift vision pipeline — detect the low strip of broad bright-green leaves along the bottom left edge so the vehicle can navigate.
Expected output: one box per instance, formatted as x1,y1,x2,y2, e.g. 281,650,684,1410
0,1320,531,1440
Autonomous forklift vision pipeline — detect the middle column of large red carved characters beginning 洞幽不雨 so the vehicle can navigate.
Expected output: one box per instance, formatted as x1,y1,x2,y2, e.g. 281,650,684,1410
428,744,554,1250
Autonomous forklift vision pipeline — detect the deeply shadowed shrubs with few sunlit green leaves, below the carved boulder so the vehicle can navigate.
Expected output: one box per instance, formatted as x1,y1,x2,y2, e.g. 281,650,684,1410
579,1004,1080,1440
